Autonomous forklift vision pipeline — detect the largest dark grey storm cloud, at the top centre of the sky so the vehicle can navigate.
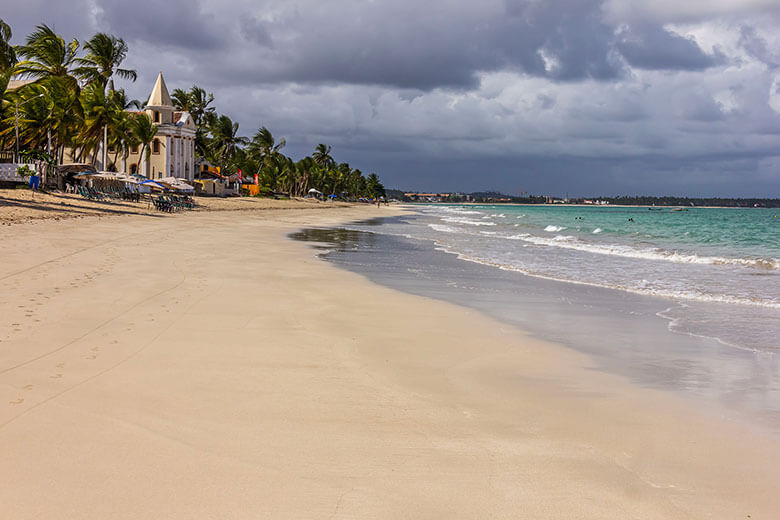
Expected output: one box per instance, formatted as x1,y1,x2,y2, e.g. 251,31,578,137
224,0,623,90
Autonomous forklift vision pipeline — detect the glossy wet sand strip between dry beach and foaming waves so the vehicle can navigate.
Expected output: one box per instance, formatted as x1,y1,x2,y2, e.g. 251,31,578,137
293,217,780,435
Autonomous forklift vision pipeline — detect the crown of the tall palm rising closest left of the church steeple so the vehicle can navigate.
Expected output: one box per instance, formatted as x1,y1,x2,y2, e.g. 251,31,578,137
74,33,138,92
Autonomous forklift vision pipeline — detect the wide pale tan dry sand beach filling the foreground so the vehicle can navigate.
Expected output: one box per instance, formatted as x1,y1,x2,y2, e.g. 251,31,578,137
0,201,780,519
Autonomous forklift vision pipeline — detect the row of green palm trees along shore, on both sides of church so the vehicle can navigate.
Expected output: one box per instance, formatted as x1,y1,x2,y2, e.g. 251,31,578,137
0,19,385,199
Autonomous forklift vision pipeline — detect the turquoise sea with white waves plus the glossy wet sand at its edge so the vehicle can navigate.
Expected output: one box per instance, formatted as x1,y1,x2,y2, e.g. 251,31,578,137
290,205,780,432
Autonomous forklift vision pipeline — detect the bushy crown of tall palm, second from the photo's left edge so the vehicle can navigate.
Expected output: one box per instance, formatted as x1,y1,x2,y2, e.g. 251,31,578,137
14,24,79,92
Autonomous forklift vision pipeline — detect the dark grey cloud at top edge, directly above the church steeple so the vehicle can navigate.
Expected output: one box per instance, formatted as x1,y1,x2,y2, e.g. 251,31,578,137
96,0,227,53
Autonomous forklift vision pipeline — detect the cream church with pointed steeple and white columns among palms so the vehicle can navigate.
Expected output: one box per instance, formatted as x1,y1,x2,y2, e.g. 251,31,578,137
126,72,195,181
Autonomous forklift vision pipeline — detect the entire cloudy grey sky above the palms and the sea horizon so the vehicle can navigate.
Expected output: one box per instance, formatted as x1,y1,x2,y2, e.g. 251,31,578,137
0,0,780,197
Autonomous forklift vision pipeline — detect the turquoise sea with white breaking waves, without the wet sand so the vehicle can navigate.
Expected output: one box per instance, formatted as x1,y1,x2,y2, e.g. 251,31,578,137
368,205,780,351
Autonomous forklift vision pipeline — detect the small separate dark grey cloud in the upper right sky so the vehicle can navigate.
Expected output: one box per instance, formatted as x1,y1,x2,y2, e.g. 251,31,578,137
617,26,725,70
